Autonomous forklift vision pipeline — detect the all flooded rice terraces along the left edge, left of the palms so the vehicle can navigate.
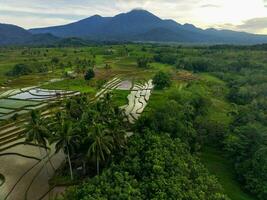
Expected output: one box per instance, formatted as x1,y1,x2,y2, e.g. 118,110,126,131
0,88,79,200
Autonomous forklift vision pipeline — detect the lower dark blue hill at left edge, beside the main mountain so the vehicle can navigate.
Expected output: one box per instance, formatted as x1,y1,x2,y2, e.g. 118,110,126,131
0,24,59,46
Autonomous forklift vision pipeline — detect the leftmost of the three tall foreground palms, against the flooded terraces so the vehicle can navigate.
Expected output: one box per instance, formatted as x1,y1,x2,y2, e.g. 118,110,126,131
25,110,55,175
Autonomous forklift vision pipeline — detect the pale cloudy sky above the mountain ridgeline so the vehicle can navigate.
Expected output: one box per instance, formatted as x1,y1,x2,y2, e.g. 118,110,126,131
0,0,267,34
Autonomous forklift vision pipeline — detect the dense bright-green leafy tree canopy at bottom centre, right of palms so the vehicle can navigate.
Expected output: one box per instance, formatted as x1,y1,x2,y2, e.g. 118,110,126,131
61,131,228,200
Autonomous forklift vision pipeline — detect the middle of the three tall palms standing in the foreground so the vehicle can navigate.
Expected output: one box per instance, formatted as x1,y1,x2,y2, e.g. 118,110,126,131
51,118,78,180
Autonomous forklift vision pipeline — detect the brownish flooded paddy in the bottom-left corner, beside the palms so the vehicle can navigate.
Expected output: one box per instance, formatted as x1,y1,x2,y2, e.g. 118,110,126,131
0,143,64,200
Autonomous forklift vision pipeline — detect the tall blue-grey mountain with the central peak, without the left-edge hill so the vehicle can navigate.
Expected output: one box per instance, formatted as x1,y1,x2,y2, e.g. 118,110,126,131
30,10,267,44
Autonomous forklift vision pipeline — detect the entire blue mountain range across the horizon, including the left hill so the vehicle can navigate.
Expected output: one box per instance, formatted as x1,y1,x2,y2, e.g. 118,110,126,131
0,10,267,45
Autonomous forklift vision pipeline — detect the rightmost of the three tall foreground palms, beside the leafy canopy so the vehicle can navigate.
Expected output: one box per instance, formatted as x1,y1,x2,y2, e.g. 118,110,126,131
88,124,113,175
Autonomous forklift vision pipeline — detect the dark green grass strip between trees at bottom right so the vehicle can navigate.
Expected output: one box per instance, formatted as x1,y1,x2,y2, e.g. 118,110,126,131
201,148,256,200
